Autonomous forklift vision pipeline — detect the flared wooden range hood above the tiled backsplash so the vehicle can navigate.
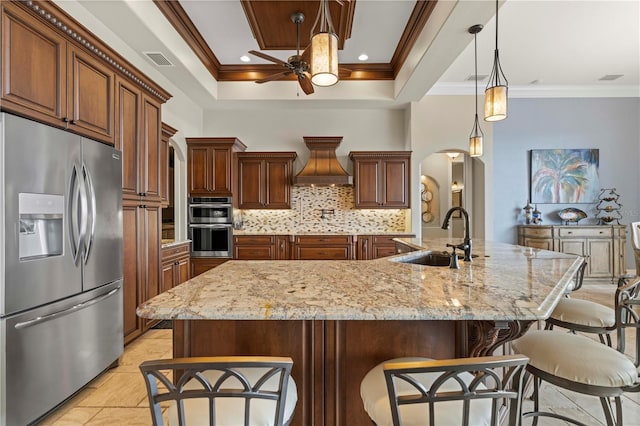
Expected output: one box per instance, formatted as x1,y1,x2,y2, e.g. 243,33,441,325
294,136,353,186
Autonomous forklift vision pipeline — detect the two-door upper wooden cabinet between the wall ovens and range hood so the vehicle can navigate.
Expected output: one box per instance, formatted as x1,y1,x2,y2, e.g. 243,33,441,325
237,152,297,209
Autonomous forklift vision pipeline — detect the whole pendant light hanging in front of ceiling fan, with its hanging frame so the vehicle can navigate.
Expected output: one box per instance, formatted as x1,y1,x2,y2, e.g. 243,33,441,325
311,0,338,86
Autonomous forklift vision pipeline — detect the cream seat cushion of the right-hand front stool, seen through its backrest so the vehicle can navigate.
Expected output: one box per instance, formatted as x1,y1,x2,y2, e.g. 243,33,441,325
360,357,491,426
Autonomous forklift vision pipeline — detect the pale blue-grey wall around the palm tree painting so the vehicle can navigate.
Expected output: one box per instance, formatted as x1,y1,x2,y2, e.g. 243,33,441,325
493,98,640,268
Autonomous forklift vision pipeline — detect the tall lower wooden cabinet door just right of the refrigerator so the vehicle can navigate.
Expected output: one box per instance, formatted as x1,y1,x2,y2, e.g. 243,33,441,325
122,200,161,344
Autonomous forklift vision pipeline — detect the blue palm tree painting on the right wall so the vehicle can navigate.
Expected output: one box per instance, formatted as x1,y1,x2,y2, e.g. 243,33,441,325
531,149,600,204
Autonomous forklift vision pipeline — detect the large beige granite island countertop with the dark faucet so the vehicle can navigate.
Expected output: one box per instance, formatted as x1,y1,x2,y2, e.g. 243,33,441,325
137,239,582,320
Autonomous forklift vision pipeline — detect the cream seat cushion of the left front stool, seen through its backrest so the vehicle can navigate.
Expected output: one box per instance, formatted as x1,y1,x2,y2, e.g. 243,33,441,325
169,368,298,426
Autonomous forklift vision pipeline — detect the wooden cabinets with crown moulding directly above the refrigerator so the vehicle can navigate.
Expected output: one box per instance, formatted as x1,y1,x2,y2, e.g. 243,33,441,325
2,1,171,146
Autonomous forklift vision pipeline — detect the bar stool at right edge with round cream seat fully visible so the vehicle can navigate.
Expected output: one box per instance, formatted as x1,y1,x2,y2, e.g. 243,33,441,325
512,277,640,426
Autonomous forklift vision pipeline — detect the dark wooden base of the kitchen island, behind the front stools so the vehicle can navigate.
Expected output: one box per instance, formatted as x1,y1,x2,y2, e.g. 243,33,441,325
173,320,458,426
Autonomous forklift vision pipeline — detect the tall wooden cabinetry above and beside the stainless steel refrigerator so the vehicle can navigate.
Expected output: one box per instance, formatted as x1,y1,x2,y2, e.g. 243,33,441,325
0,1,171,343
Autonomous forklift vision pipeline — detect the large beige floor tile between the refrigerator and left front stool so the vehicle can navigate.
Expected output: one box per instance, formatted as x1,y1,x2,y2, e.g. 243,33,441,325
78,372,147,407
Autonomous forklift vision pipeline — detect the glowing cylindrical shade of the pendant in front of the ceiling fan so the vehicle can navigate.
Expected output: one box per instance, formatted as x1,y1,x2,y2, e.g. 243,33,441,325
311,32,338,86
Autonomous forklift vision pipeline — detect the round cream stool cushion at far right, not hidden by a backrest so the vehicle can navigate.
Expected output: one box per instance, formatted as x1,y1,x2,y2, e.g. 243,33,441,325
512,330,638,388
